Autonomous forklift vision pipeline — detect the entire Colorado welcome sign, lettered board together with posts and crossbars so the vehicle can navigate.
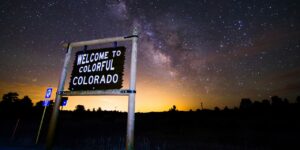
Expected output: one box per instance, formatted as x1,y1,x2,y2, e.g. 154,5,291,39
46,28,138,150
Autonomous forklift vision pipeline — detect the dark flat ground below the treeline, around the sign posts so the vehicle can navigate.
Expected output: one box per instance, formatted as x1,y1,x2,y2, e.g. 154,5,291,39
0,107,300,150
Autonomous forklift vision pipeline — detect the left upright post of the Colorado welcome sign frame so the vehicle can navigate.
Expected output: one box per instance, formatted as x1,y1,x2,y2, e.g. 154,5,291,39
46,44,72,150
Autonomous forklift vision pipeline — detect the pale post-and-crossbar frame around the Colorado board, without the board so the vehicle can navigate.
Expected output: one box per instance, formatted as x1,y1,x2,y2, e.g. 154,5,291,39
46,27,138,150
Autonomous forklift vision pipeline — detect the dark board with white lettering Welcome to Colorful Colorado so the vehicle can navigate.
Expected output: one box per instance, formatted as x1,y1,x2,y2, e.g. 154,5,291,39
69,47,126,91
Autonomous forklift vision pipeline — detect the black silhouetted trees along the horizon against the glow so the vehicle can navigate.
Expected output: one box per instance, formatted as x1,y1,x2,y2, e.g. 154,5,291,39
0,92,300,117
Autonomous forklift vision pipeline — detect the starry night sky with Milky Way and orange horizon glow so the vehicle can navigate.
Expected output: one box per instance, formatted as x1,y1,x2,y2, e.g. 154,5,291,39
0,0,300,112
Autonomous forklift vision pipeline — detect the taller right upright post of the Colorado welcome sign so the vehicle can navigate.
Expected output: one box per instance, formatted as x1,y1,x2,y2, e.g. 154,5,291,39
126,27,138,150
